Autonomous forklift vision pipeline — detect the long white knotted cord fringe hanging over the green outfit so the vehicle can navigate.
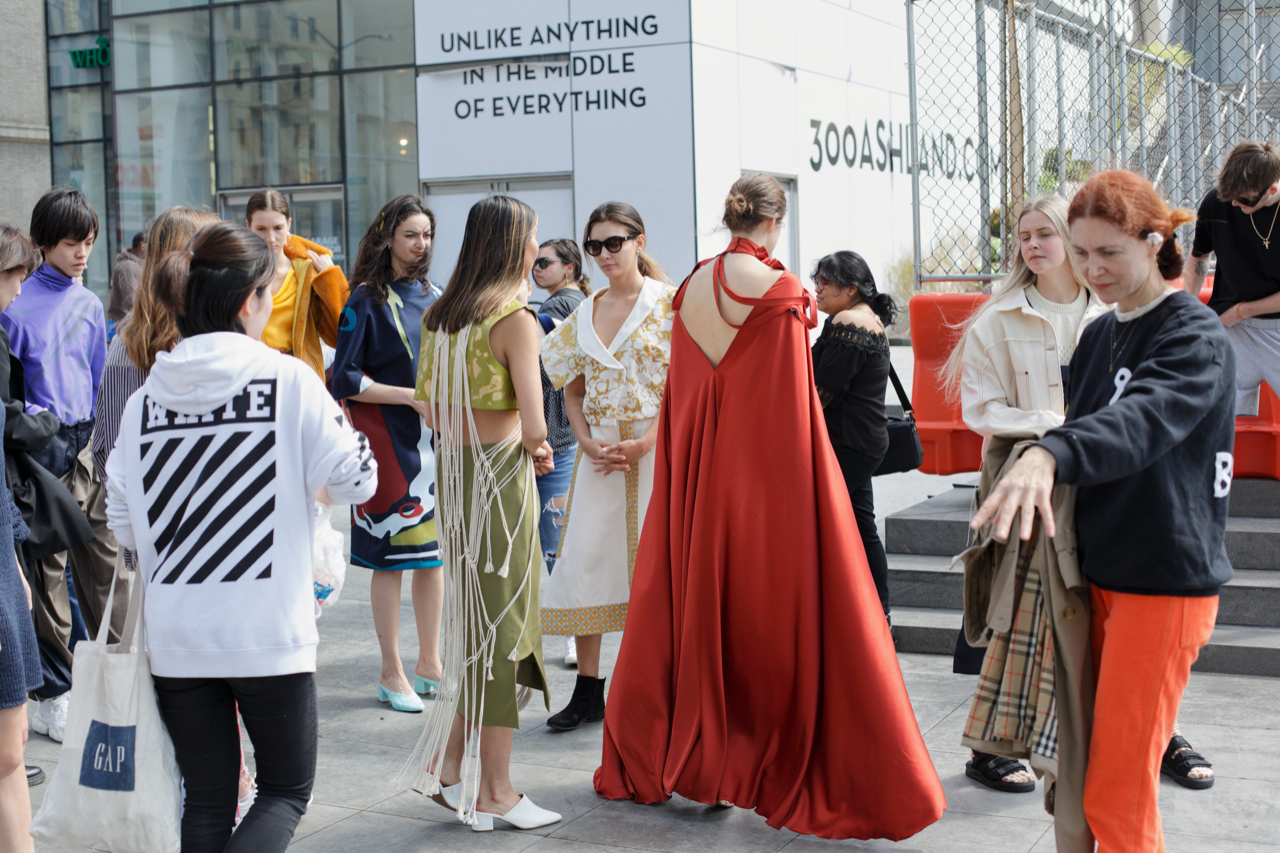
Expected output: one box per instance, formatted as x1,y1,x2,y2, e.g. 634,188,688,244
396,327,538,824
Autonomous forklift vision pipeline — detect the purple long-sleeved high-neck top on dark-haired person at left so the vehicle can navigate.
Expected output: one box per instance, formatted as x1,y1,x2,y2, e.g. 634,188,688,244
0,258,106,424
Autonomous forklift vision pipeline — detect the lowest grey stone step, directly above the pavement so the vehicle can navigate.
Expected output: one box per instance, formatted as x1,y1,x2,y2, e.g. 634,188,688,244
893,606,1280,678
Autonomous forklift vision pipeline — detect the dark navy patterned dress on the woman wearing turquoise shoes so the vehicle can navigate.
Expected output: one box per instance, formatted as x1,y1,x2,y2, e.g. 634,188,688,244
333,282,440,571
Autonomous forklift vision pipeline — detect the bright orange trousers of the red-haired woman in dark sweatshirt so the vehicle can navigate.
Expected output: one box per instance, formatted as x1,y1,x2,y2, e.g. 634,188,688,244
1084,587,1217,853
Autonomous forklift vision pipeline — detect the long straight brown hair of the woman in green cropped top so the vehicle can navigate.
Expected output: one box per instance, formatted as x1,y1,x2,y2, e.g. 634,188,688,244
422,196,538,334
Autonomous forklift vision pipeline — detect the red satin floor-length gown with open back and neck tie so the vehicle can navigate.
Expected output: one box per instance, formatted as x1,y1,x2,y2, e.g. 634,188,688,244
595,238,946,840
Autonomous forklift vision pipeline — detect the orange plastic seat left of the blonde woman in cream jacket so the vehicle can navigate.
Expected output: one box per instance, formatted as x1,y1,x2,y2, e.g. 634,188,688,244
908,293,988,474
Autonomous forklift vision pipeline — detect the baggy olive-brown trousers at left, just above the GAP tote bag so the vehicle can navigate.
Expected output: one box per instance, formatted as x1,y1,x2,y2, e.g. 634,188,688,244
29,442,129,663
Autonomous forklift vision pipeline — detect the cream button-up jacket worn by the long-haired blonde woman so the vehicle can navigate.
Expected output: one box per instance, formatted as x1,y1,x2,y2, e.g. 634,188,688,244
960,288,1111,438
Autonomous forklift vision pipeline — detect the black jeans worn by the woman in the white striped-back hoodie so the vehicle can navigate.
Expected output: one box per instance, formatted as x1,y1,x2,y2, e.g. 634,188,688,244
154,672,317,853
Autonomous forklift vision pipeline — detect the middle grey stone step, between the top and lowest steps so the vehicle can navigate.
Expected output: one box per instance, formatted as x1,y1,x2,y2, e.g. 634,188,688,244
888,553,1280,628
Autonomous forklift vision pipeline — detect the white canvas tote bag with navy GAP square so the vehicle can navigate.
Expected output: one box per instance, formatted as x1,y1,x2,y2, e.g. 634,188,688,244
31,548,182,853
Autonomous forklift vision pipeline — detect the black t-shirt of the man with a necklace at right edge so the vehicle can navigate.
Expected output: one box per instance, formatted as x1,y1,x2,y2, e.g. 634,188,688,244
1192,187,1280,320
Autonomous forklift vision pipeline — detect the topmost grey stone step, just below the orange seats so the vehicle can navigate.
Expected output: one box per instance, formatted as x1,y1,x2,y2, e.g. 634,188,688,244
884,480,1280,570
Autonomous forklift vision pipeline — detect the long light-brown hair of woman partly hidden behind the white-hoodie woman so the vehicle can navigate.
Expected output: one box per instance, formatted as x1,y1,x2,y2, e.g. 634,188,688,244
120,207,221,370
